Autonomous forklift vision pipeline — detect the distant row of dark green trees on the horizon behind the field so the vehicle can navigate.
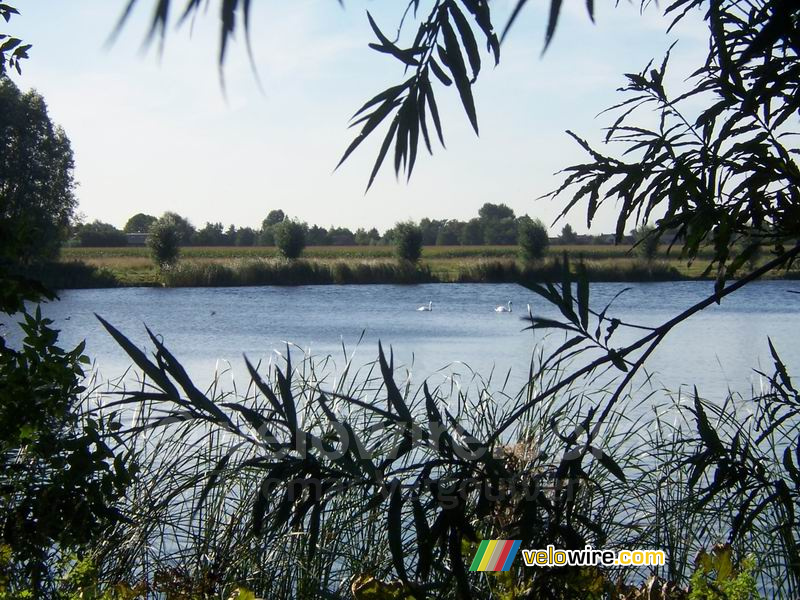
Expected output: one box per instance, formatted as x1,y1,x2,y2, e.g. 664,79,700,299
69,202,609,247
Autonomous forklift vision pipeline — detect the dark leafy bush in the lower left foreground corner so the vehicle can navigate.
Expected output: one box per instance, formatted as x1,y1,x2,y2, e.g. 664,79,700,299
0,307,134,597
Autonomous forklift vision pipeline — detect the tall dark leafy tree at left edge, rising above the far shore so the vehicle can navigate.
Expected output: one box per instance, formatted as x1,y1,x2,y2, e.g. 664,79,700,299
0,76,76,265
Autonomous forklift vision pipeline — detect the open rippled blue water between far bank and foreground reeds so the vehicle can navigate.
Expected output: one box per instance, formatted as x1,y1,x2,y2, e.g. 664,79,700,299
6,281,800,404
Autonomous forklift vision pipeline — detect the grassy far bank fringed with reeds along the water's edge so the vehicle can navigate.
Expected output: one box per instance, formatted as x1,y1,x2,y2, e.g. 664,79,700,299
51,245,800,288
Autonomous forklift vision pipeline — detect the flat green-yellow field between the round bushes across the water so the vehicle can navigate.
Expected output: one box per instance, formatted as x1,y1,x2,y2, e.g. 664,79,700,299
60,245,788,286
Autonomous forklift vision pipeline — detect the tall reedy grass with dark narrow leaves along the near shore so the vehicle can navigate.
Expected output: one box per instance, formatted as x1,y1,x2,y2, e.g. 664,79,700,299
75,326,798,598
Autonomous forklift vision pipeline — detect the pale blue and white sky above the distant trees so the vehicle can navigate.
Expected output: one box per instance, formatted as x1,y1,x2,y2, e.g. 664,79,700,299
4,0,707,234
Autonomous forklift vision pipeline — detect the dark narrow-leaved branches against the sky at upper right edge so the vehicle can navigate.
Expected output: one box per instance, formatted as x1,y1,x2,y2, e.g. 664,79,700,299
552,0,800,289
